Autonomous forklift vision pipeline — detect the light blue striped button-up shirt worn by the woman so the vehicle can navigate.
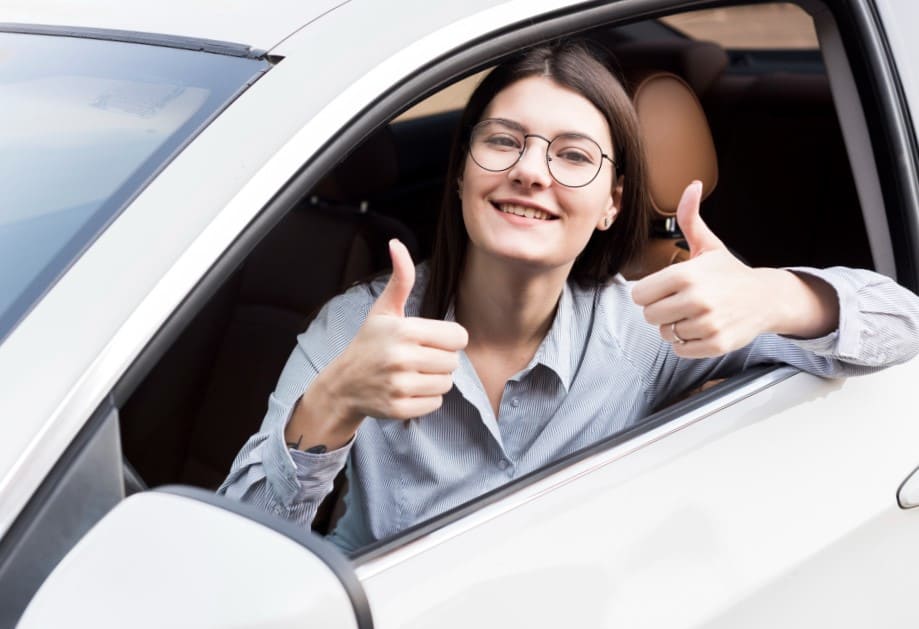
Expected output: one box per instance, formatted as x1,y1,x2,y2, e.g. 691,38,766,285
218,264,919,550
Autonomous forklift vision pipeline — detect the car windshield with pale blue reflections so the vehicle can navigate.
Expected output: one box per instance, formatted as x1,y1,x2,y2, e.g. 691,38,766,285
0,33,268,339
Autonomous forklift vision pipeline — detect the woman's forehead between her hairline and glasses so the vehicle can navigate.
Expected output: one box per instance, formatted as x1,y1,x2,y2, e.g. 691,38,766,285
482,76,610,145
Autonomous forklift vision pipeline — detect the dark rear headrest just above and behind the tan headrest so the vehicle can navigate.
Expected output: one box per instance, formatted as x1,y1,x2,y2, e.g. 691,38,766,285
614,39,729,94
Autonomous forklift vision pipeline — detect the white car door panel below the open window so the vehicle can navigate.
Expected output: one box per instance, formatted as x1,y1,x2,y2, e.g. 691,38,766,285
358,361,919,629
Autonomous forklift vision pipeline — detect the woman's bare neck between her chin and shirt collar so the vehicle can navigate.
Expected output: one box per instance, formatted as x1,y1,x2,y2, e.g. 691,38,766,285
455,251,569,349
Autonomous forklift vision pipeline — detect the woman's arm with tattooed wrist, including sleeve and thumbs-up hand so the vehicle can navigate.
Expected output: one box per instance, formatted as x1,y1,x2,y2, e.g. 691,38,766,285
218,244,467,525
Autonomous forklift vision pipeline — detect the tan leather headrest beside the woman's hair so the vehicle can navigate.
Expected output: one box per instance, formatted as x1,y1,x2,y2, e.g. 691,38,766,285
632,72,718,218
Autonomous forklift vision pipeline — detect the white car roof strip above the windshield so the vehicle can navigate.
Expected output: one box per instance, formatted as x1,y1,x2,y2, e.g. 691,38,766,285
0,0,348,50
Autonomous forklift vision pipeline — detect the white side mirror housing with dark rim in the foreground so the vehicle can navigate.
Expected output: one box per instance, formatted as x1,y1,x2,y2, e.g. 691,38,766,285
18,487,371,629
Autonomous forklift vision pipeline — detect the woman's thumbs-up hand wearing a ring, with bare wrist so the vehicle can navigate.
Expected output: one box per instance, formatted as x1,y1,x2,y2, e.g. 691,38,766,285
632,182,839,358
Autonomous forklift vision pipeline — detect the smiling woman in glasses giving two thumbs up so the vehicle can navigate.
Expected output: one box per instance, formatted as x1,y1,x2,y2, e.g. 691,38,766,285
220,43,919,549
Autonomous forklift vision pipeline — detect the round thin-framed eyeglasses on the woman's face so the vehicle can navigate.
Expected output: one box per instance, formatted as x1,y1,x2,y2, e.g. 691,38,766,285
469,118,617,188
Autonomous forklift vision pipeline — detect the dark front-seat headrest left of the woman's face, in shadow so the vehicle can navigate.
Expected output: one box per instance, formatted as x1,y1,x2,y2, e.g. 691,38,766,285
314,127,399,205
